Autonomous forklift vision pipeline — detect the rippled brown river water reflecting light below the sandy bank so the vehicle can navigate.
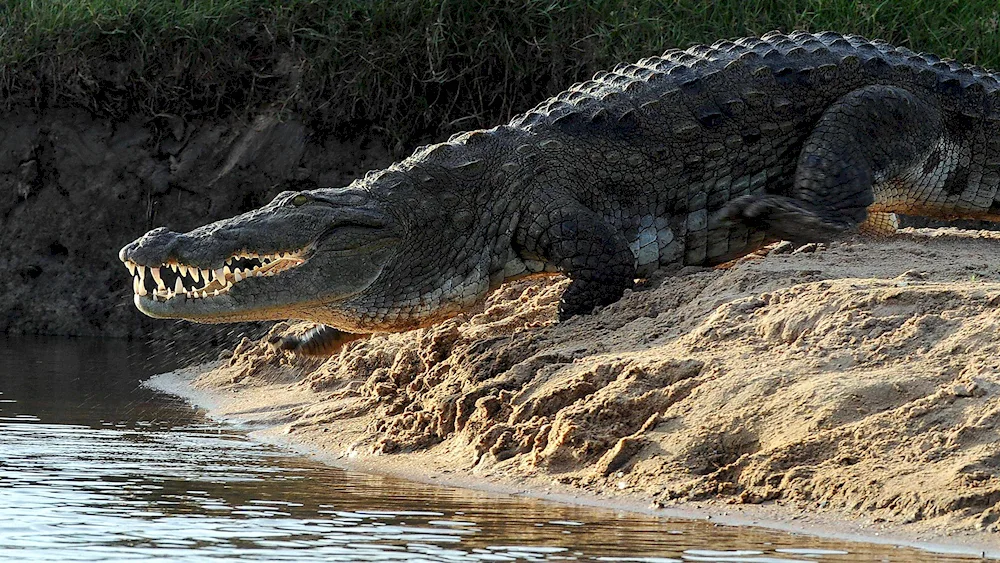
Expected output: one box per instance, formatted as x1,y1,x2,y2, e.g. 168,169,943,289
0,336,984,563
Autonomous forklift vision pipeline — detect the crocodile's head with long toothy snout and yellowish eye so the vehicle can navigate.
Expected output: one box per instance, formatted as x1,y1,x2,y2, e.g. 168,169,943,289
119,187,403,330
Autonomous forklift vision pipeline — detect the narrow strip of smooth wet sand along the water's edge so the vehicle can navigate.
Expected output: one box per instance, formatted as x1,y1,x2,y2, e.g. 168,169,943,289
152,363,1000,560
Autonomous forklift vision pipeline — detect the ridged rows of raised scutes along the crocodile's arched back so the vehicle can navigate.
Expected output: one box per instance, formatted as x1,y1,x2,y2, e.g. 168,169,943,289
510,31,1000,134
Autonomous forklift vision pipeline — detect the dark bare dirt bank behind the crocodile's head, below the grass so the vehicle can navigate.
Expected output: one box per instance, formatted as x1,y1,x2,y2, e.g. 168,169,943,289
0,109,391,338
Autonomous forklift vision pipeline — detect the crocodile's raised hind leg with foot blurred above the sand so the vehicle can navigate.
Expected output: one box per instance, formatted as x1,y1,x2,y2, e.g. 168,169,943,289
723,85,942,242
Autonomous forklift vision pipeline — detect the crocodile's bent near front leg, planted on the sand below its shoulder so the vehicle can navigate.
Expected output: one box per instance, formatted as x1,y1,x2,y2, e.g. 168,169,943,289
515,197,635,321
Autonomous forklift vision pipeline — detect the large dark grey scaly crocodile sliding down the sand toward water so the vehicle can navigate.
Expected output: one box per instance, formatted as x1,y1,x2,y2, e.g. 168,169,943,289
120,32,1000,353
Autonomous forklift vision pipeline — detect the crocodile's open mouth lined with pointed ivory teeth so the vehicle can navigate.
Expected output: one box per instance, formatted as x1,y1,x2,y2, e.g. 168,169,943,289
123,249,309,301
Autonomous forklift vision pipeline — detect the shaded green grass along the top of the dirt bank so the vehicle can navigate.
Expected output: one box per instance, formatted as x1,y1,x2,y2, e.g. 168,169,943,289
0,0,1000,140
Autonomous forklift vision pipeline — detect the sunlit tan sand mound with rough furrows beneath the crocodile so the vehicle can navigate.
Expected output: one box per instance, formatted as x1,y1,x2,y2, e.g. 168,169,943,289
152,229,1000,553
